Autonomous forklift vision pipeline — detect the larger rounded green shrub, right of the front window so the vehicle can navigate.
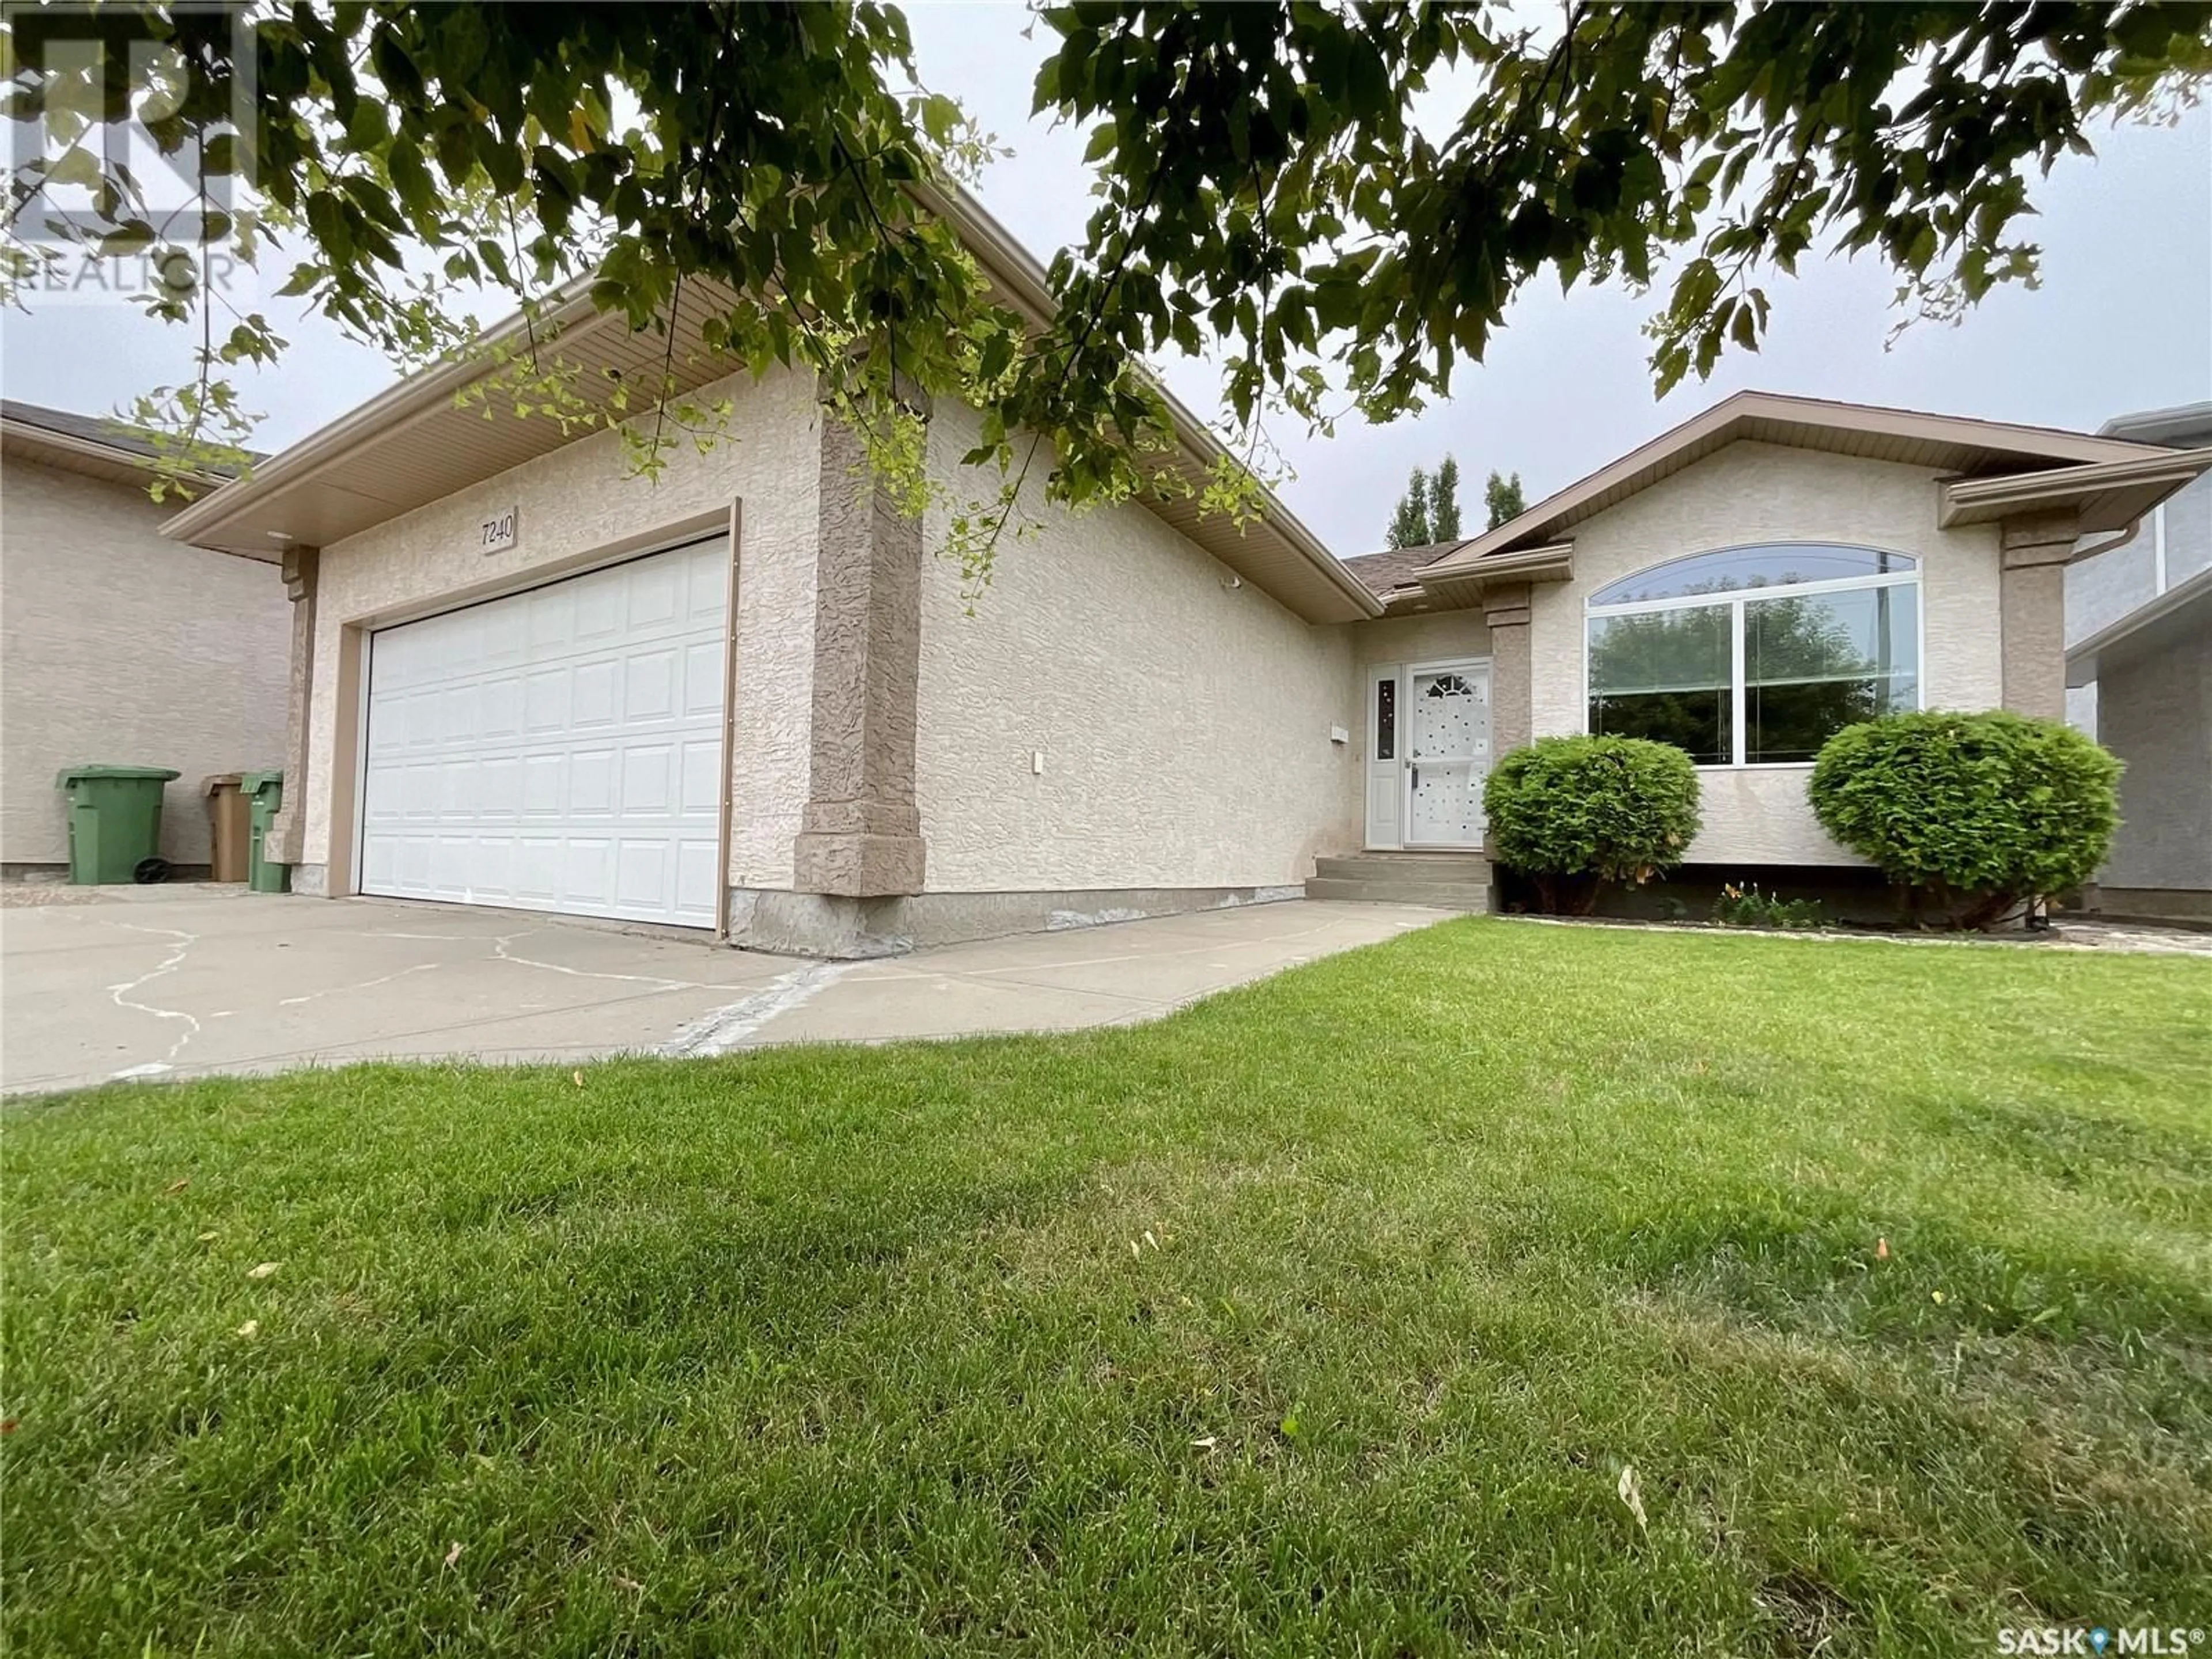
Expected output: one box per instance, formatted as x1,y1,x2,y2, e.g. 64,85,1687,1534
1812,712,2119,927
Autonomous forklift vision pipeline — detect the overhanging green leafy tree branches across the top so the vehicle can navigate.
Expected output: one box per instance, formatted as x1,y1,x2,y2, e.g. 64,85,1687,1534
5,0,2212,571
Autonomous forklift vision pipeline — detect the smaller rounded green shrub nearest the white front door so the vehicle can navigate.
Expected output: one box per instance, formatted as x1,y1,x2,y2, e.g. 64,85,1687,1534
1482,737,1696,914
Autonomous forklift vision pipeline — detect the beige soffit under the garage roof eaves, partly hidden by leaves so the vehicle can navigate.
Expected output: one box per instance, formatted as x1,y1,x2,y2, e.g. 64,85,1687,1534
164,186,1382,622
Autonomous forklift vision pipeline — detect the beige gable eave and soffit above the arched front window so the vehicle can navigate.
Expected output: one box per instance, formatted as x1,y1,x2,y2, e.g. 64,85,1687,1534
1422,392,2175,586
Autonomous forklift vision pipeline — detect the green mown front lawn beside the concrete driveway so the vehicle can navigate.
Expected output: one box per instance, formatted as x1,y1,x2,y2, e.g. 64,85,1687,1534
0,920,2212,1659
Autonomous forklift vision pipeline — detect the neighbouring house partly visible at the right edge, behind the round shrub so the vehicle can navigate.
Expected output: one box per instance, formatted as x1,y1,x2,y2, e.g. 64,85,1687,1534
2066,403,2212,922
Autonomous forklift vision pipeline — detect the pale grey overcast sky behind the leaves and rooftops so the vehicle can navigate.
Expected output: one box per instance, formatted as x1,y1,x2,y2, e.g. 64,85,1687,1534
0,2,2212,553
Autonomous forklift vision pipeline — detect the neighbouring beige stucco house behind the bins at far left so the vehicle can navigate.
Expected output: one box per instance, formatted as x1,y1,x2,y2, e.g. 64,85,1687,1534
0,403,292,880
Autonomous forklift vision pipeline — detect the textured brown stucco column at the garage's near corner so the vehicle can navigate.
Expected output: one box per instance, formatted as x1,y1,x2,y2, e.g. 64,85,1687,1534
792,409,927,898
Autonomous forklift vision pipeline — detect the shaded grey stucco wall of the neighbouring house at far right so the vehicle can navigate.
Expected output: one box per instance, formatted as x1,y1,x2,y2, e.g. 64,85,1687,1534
2097,610,2212,892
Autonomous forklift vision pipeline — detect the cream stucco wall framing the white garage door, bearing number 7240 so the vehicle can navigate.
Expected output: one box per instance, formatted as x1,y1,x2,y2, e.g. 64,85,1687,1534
303,362,821,887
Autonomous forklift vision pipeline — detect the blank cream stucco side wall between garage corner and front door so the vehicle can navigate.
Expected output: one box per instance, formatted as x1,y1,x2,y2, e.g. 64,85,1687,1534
916,403,1361,892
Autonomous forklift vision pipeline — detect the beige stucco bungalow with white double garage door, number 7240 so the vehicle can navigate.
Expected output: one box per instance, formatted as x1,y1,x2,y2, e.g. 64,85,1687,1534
156,197,2212,956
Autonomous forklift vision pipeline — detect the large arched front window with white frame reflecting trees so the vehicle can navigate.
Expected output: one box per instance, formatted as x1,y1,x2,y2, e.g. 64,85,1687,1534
1588,553,1920,766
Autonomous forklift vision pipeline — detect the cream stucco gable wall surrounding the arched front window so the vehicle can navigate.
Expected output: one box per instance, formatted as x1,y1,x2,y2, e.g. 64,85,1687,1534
1528,442,2004,865
